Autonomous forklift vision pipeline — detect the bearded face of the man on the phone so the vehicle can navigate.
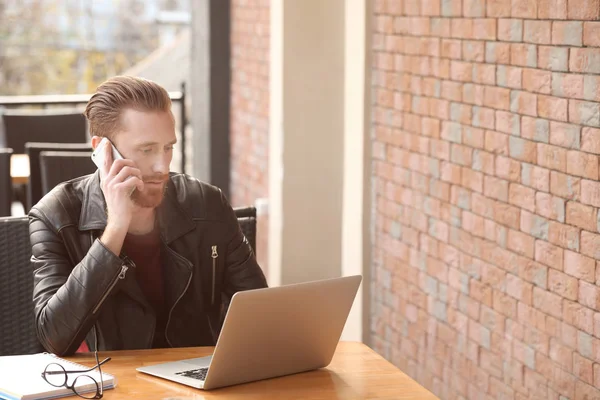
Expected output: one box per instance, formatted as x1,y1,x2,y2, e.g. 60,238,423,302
112,109,176,208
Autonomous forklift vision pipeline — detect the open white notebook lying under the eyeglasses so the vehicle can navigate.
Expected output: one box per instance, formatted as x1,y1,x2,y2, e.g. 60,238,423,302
0,353,117,400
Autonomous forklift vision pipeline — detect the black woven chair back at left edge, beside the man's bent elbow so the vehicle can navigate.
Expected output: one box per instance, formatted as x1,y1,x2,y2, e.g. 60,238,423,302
0,217,44,356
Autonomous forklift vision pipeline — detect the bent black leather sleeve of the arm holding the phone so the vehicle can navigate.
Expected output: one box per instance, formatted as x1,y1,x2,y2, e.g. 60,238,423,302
29,208,124,356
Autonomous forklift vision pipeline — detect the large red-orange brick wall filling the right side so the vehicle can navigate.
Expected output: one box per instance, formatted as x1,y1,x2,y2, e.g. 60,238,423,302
371,0,600,400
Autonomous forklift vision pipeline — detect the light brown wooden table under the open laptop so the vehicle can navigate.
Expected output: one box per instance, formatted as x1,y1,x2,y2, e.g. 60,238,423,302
68,342,437,400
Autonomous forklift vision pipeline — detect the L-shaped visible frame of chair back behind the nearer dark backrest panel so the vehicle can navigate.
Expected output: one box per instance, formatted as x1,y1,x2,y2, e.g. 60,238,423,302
25,142,92,211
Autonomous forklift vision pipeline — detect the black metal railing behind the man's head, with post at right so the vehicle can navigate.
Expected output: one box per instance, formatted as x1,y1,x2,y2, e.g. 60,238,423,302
0,82,187,174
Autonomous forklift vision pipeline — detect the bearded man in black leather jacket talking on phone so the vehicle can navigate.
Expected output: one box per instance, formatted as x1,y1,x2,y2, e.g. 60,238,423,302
29,77,267,355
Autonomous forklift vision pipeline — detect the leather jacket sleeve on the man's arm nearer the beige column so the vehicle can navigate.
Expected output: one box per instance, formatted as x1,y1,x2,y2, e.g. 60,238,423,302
221,193,267,299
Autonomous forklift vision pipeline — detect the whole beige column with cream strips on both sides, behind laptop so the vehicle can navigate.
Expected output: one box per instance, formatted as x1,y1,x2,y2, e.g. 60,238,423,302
268,0,370,341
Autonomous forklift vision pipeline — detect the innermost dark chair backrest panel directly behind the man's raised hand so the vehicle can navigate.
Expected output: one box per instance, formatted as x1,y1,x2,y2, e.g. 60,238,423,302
40,151,97,196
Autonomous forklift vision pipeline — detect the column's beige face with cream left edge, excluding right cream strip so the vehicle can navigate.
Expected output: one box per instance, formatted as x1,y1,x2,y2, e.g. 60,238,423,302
269,0,345,285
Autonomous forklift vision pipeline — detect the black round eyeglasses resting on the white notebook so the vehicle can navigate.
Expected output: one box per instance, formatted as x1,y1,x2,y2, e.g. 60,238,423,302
42,351,110,399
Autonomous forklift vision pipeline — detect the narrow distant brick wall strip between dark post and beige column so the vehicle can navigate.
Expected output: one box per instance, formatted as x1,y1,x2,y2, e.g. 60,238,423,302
230,0,270,269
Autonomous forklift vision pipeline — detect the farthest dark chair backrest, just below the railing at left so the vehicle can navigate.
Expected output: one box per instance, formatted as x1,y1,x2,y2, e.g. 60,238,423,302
0,110,87,154
